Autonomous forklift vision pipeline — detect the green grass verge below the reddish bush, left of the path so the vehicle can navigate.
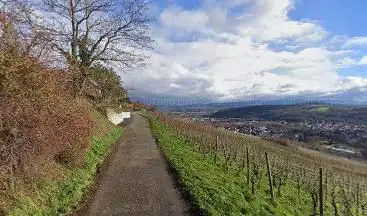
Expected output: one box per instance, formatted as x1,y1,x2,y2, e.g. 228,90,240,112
8,112,122,215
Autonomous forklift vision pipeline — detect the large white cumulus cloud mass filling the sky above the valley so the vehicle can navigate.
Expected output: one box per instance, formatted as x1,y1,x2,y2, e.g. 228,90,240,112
125,0,367,100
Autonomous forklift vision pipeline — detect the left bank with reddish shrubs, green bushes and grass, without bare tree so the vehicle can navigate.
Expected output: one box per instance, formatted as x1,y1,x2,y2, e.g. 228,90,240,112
0,1,129,216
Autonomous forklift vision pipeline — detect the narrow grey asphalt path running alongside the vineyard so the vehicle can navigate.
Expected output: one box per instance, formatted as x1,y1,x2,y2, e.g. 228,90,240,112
78,115,189,216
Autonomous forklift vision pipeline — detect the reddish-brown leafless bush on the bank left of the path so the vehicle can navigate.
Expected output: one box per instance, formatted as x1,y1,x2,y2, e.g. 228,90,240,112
0,47,92,186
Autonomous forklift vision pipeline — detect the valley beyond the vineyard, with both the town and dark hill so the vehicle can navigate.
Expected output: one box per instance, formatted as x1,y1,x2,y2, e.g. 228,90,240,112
176,104,367,160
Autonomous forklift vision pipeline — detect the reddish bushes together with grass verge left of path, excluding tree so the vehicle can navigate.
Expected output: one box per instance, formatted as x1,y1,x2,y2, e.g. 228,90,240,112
0,35,122,215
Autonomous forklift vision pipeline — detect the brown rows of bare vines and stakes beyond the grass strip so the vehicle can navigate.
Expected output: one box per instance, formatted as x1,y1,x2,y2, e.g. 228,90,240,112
152,113,367,216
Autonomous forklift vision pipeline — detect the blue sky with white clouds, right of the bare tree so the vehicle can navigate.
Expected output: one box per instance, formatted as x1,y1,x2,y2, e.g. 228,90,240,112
125,0,367,100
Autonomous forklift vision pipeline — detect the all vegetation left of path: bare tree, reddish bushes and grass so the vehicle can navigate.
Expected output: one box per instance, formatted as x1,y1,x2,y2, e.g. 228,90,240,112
0,0,150,215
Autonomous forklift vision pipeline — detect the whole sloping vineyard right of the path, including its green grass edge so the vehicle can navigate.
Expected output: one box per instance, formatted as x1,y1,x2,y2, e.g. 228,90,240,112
150,113,367,216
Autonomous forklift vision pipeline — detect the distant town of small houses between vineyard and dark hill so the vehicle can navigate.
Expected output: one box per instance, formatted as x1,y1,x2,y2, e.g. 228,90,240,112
174,103,367,159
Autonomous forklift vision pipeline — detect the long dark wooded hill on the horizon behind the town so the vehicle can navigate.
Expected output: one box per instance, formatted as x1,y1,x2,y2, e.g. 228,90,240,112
212,104,367,122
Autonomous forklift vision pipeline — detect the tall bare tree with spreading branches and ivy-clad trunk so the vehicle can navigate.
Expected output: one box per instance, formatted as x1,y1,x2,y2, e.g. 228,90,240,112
32,0,152,92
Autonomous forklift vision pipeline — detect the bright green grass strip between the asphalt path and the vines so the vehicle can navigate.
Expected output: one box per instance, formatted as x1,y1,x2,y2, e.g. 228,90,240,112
150,116,336,216
